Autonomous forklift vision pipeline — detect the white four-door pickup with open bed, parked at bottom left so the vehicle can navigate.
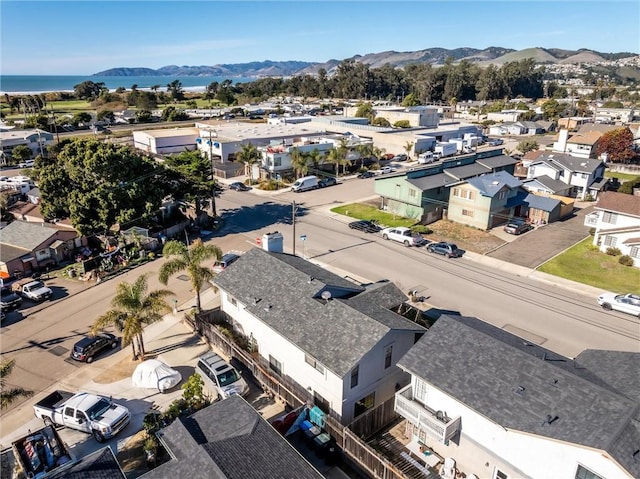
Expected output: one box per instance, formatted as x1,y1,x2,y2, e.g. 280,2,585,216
33,391,131,442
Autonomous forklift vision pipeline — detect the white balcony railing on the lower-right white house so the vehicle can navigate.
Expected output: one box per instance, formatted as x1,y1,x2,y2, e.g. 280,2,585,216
395,385,460,443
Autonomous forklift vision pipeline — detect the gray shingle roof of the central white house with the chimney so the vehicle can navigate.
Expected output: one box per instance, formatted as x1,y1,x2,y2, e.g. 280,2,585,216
214,248,423,377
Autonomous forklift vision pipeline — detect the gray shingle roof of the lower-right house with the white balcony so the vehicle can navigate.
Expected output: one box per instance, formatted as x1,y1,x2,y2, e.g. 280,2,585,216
398,315,640,477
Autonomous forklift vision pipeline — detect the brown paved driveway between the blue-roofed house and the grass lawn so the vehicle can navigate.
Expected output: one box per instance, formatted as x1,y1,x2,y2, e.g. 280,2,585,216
487,206,593,269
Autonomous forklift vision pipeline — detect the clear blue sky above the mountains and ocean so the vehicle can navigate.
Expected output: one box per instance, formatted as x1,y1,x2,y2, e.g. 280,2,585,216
0,0,640,75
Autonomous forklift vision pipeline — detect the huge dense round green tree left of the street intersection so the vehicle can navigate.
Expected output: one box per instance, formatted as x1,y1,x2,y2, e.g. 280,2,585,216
38,138,169,235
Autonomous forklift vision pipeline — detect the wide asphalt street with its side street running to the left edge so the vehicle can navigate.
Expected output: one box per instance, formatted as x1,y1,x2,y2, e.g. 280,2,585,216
1,179,640,424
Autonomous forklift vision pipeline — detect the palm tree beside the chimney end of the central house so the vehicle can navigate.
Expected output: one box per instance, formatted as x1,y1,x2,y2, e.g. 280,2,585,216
158,238,222,312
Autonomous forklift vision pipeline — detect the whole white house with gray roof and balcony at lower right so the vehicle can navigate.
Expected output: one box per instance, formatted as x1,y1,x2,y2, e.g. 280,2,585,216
395,315,640,479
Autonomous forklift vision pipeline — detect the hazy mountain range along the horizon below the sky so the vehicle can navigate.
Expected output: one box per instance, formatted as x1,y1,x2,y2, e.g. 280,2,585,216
94,47,637,77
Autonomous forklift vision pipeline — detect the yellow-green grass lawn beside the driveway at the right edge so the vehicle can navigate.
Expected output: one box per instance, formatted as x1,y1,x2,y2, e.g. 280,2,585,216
538,237,640,294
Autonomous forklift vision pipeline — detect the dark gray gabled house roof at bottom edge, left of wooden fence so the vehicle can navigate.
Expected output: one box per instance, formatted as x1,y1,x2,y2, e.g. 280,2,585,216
145,396,323,479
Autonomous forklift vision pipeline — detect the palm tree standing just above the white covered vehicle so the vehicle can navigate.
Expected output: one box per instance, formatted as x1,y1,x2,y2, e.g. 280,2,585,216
91,274,173,359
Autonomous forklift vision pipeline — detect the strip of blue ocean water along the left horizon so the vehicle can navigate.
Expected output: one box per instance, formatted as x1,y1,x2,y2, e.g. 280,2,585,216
0,75,256,95
